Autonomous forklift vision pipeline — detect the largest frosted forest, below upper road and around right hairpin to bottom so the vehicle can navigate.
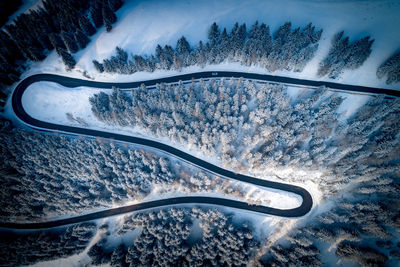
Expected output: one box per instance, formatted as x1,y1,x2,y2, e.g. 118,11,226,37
87,79,400,266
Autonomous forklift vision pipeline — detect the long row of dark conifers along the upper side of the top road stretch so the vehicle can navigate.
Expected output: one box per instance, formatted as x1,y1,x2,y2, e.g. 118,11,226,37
93,22,322,74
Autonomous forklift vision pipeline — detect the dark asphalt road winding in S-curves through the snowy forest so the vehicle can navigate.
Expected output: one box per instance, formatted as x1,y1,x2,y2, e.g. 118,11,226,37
4,71,400,229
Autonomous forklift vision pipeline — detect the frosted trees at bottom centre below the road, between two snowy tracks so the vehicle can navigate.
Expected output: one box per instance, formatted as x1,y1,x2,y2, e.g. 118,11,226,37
88,208,259,266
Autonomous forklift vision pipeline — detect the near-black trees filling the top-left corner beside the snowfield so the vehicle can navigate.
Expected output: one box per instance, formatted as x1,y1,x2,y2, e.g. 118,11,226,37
0,0,122,98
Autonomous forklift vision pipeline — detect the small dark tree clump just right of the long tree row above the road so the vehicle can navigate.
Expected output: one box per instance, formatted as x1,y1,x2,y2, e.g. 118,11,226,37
318,31,374,79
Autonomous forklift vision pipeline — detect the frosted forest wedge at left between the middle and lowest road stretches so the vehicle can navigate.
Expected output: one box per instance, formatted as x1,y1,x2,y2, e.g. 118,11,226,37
0,119,178,221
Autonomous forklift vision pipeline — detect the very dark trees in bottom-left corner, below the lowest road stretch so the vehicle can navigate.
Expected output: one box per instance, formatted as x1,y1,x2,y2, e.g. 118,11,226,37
0,223,97,266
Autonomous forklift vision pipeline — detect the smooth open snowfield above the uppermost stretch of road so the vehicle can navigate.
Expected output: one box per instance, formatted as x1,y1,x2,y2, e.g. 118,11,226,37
11,0,400,93
